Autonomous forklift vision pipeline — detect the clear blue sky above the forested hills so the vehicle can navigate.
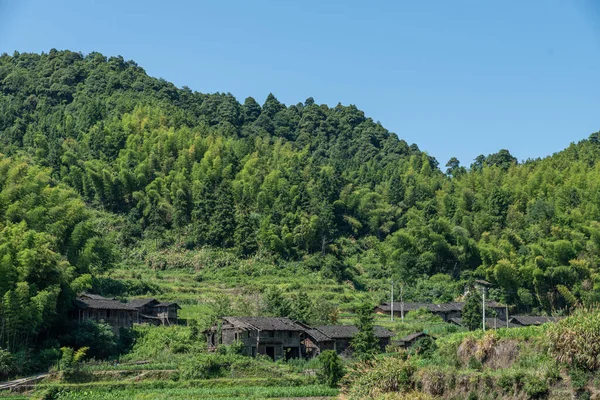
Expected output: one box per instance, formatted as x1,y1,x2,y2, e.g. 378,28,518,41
0,0,600,165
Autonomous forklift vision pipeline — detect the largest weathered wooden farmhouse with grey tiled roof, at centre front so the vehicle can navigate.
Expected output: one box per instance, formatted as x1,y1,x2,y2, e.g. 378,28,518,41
205,317,305,360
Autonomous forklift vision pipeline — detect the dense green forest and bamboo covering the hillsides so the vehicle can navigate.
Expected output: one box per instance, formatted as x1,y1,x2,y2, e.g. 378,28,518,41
0,50,600,360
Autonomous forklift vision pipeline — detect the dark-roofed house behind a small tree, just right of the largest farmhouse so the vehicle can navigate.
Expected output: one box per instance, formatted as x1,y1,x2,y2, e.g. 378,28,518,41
304,325,394,357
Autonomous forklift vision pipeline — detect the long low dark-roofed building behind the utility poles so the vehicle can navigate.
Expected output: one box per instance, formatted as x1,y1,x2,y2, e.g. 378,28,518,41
375,301,506,322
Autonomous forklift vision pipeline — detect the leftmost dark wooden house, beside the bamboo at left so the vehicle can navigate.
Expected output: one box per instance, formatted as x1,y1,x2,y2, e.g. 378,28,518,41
71,293,138,335
